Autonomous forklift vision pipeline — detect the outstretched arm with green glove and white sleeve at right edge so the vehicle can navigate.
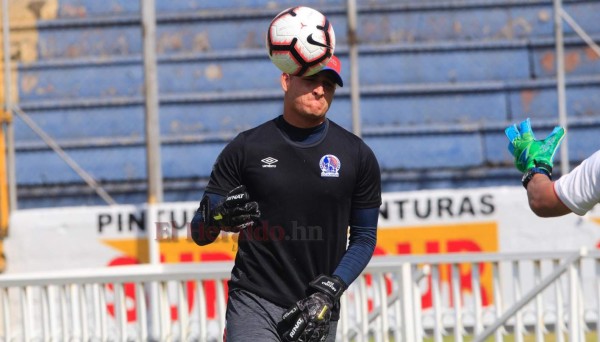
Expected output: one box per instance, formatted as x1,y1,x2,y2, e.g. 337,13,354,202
505,119,600,217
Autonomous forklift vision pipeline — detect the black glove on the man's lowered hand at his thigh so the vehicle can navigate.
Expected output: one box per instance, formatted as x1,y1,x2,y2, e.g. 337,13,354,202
281,274,346,342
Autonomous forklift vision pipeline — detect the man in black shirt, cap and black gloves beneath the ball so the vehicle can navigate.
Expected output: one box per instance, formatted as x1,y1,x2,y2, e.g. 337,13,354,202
191,56,381,342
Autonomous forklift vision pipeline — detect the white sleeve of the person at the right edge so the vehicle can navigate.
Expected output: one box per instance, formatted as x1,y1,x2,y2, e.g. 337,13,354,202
554,151,600,215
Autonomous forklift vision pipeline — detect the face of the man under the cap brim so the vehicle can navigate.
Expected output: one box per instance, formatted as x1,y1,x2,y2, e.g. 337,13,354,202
281,71,336,127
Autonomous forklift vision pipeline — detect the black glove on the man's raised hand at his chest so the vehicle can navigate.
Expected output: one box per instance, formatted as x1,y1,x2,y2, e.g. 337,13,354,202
198,185,260,233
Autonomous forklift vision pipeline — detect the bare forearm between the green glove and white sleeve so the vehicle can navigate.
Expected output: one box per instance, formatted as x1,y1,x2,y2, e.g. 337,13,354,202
527,173,571,217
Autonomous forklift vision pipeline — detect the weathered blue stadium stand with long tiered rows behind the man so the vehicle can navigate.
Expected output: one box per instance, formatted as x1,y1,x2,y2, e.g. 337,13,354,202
8,0,600,208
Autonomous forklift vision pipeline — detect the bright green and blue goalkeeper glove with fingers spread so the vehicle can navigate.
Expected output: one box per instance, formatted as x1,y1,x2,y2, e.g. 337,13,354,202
504,118,565,175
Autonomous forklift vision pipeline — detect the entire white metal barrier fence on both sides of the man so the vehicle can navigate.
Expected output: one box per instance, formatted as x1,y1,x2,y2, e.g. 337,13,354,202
0,250,600,342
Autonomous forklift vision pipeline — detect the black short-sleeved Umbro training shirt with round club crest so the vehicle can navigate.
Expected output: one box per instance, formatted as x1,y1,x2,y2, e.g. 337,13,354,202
206,117,381,307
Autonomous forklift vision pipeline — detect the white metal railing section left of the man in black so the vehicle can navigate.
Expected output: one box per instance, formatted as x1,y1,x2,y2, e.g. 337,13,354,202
0,262,231,341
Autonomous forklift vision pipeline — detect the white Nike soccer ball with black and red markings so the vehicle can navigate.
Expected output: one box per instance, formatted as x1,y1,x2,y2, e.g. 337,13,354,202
267,6,335,76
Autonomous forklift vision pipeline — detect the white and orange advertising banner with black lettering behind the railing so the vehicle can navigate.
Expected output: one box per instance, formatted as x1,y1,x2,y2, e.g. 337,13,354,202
5,187,600,319
